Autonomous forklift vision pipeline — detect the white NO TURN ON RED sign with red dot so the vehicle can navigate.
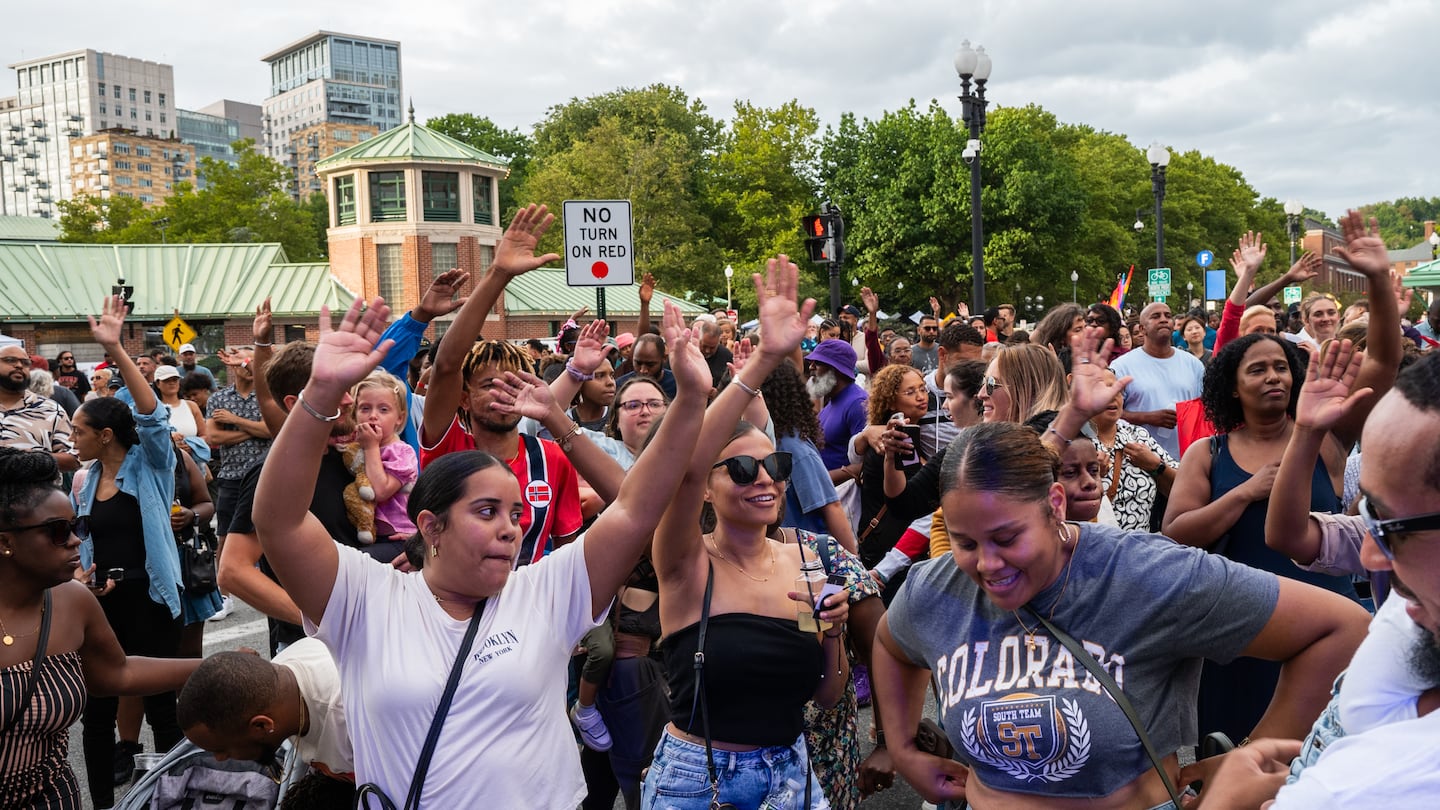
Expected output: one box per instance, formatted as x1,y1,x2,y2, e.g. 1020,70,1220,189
564,200,635,287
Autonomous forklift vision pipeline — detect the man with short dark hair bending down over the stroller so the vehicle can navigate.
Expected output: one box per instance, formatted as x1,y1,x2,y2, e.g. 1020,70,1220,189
176,638,354,784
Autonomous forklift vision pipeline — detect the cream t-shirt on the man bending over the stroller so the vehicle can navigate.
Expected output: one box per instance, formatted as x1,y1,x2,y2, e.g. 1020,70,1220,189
272,638,356,775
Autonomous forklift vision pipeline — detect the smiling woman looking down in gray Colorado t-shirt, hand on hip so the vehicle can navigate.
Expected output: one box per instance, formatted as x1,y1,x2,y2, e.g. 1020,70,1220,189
873,415,1368,810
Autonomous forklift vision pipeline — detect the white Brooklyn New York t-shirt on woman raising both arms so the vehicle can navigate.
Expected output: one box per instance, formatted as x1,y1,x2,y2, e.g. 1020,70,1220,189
305,538,605,807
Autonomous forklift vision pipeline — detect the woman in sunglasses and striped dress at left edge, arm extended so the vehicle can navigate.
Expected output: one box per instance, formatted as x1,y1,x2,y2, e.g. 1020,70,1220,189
0,447,199,810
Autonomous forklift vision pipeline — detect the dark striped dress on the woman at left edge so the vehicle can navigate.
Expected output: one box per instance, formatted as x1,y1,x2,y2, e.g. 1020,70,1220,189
0,651,85,810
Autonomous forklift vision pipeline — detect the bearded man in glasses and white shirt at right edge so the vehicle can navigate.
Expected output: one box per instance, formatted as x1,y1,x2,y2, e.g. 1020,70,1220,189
1200,348,1440,810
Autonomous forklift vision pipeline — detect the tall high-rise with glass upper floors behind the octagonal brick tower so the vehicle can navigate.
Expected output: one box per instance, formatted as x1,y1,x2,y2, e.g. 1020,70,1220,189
261,30,403,199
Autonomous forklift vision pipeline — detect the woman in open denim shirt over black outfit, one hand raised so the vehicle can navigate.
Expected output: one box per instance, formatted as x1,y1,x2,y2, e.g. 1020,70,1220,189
72,297,191,807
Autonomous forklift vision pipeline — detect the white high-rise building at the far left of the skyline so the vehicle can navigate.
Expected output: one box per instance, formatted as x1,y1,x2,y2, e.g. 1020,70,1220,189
0,49,176,216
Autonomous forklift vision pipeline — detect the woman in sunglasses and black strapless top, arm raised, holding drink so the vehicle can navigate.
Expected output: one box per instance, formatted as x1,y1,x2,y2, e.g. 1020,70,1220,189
641,255,848,810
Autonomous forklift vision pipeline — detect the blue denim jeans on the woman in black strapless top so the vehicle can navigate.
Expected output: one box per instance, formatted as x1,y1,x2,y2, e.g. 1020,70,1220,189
639,731,829,810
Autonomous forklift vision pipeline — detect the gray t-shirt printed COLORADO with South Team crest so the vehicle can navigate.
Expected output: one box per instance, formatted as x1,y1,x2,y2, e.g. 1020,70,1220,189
887,523,1280,797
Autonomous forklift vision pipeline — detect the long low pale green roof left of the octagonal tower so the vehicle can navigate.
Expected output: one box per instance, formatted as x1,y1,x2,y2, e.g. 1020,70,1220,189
0,242,353,323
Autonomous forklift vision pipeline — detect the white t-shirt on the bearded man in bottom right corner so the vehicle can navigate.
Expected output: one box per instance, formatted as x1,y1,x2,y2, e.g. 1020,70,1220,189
1272,712,1440,810
